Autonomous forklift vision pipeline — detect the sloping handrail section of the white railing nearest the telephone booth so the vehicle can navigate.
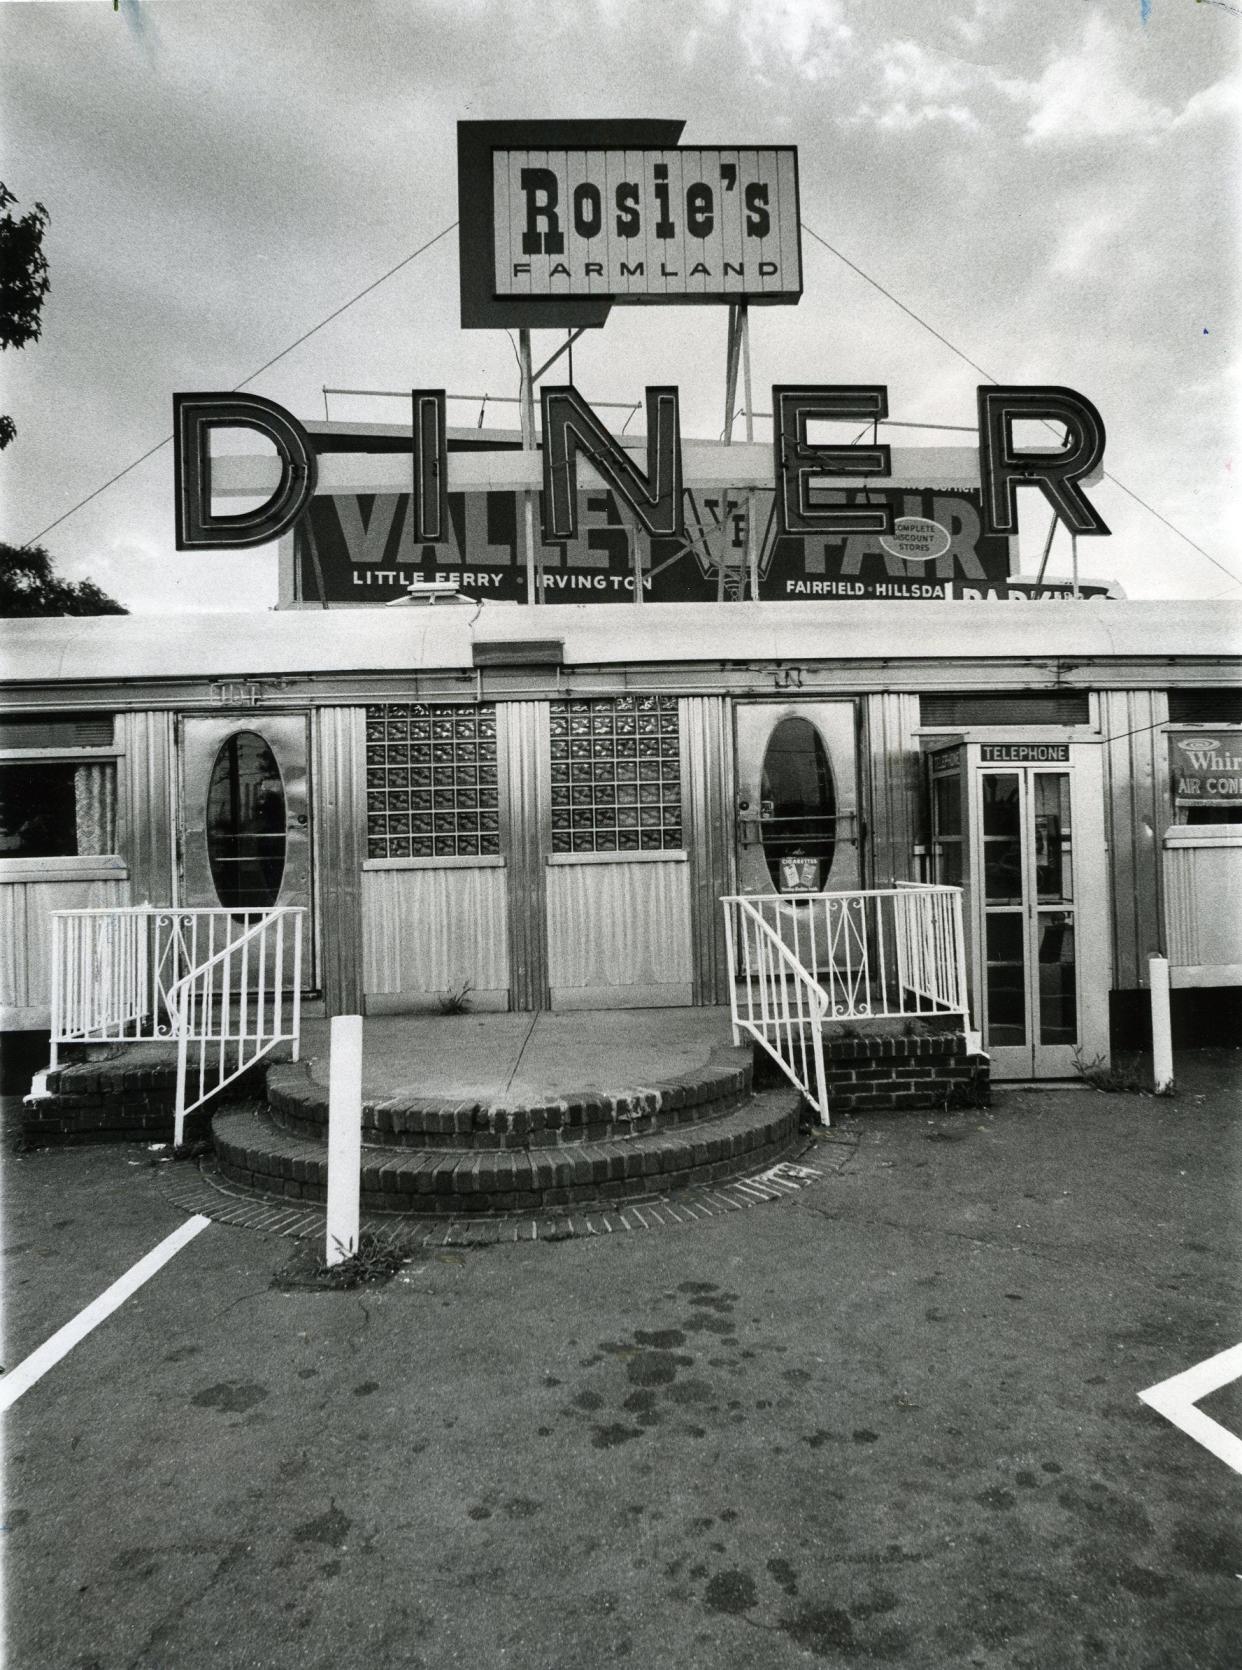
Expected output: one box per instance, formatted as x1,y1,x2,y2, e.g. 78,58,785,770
721,898,828,1126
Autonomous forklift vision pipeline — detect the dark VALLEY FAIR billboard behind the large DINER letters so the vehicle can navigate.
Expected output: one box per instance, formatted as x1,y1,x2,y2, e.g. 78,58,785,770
282,488,1110,606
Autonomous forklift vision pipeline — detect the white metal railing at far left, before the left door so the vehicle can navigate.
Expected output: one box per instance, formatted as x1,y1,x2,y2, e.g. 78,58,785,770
48,905,305,1144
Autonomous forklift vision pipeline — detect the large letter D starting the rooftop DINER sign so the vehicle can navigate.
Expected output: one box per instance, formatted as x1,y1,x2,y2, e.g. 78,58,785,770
172,394,317,551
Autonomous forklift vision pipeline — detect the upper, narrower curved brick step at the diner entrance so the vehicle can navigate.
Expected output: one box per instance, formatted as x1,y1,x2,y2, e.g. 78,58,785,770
267,1045,753,1151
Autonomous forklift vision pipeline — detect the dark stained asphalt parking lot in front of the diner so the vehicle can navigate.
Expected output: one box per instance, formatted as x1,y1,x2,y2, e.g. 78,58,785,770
3,1050,1242,1670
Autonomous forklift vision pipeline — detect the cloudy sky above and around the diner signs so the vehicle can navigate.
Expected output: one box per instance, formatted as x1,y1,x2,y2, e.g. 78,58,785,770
0,0,1242,611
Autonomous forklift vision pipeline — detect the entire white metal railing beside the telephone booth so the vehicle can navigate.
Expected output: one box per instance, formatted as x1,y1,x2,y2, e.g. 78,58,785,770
721,882,977,1124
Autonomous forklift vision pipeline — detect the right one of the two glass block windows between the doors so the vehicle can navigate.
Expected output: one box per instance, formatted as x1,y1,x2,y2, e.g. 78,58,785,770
551,696,681,852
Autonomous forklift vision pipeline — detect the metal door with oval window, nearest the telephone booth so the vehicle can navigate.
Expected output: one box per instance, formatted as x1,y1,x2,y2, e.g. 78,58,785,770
735,701,861,960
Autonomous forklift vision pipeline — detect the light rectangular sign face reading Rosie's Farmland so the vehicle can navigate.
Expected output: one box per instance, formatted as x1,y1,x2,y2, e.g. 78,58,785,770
492,145,801,302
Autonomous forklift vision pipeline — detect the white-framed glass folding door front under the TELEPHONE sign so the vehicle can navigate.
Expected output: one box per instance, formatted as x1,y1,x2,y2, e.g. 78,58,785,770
970,745,1108,1079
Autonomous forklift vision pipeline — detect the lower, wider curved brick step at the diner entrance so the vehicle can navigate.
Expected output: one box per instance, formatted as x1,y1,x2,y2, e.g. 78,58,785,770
212,1089,800,1214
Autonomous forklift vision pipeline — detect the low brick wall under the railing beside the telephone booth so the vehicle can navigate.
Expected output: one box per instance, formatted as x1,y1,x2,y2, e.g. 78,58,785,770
823,1032,992,1119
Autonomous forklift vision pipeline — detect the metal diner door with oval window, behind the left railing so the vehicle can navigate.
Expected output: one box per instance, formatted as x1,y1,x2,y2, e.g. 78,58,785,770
177,711,314,987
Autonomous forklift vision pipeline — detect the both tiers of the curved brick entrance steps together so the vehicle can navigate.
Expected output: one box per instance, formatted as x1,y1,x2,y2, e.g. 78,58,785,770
212,1050,801,1216
